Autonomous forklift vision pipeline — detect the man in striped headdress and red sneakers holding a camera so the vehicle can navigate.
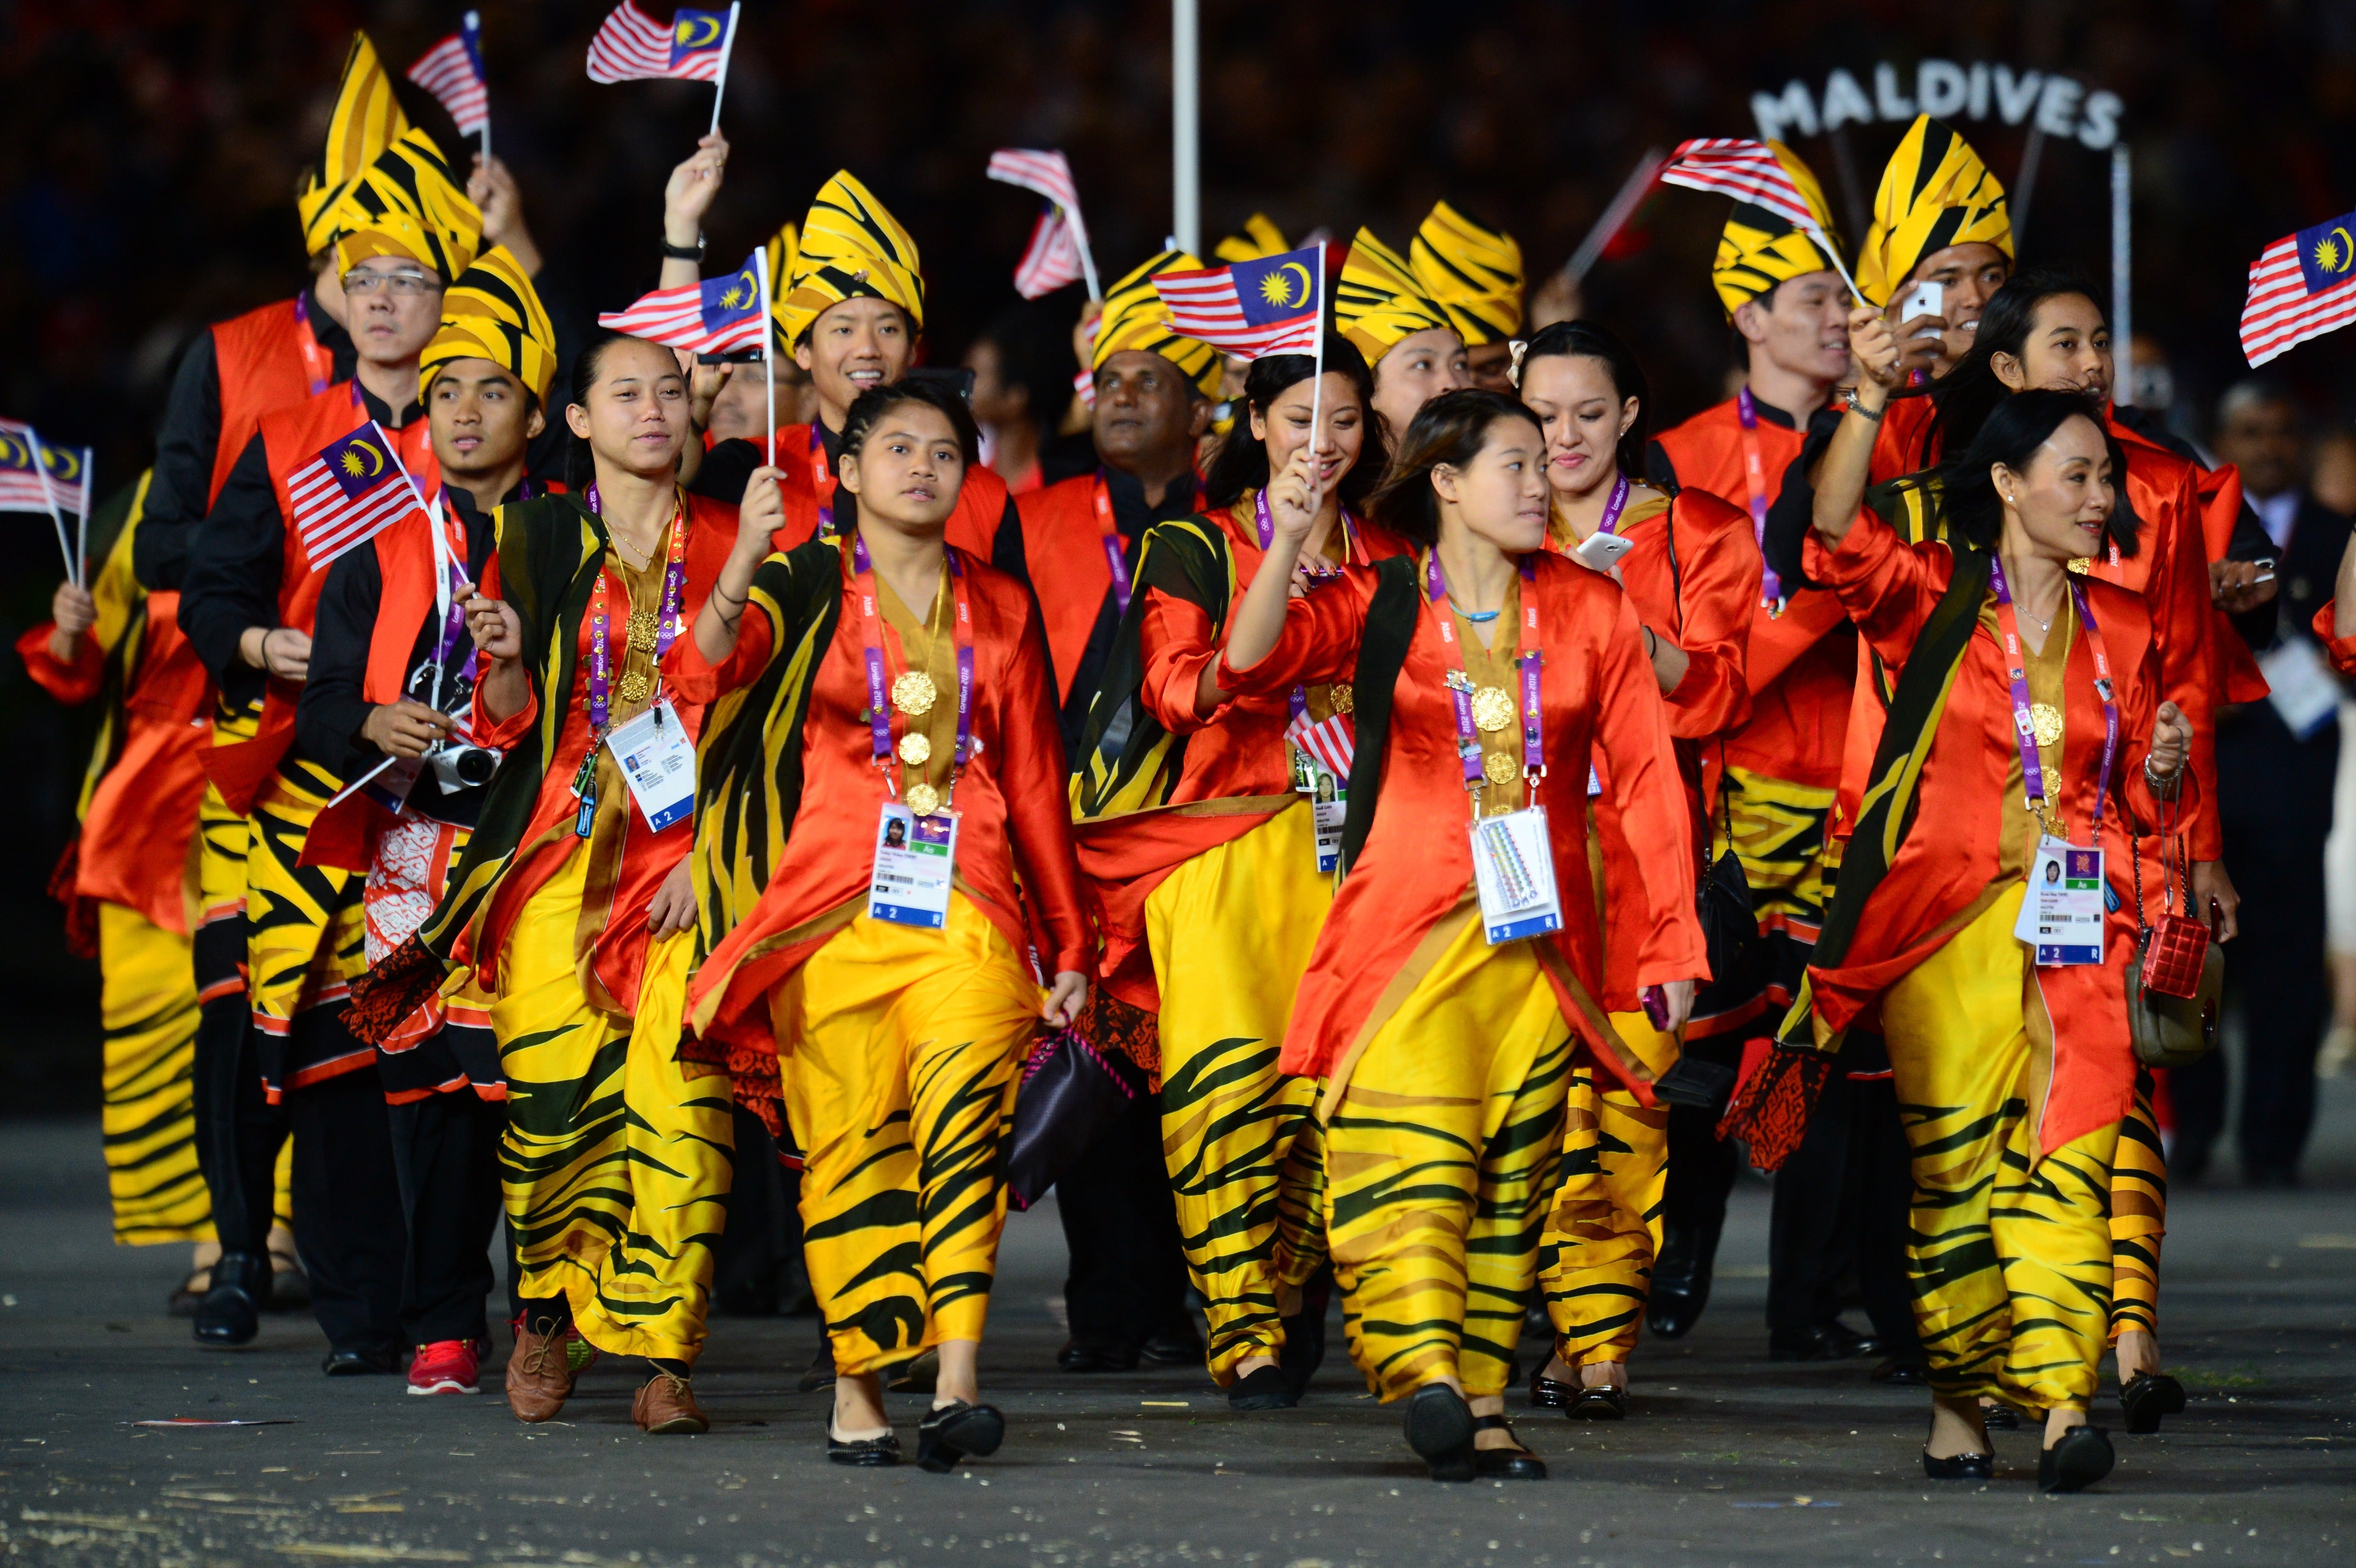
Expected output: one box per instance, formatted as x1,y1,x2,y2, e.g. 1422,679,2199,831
294,238,556,1394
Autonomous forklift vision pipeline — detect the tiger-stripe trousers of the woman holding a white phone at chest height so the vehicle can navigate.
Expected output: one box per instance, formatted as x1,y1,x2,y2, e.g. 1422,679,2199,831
1538,1013,1678,1365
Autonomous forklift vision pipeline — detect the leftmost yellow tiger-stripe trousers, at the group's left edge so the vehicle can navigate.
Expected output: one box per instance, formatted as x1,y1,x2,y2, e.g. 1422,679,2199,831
99,904,212,1245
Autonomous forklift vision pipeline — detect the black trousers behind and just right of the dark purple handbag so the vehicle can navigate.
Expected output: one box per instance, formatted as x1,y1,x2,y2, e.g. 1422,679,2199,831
1056,1095,1188,1347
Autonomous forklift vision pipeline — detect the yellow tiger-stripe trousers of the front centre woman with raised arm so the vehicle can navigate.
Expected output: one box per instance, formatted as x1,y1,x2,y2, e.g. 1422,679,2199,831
1320,911,1571,1403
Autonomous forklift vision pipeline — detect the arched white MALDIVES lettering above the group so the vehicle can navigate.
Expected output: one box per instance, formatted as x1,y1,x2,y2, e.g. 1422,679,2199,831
1751,59,2125,151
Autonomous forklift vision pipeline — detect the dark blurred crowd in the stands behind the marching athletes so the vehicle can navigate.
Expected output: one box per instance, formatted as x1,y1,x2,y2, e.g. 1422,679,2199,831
0,0,2356,1111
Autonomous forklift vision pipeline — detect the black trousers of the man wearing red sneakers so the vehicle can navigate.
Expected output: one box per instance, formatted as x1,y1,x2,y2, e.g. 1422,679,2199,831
386,1088,516,1344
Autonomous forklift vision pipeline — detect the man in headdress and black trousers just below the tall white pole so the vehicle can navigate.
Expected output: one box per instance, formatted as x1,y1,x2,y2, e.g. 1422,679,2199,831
1018,250,1223,1372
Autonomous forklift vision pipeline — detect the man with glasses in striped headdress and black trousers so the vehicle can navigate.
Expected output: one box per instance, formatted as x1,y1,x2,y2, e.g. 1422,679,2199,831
181,130,480,1375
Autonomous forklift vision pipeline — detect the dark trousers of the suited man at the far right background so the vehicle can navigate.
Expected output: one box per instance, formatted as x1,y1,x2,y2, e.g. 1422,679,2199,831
2170,702,2340,1179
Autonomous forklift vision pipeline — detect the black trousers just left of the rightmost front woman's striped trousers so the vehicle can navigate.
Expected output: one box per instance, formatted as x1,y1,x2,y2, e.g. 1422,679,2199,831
1767,1036,1918,1359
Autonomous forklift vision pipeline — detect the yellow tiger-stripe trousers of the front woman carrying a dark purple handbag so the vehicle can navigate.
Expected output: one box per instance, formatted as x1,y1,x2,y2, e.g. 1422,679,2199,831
770,893,1039,1372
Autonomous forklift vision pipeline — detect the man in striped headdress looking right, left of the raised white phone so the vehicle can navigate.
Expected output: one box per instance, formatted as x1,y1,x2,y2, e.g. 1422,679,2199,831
1647,143,1920,1377
